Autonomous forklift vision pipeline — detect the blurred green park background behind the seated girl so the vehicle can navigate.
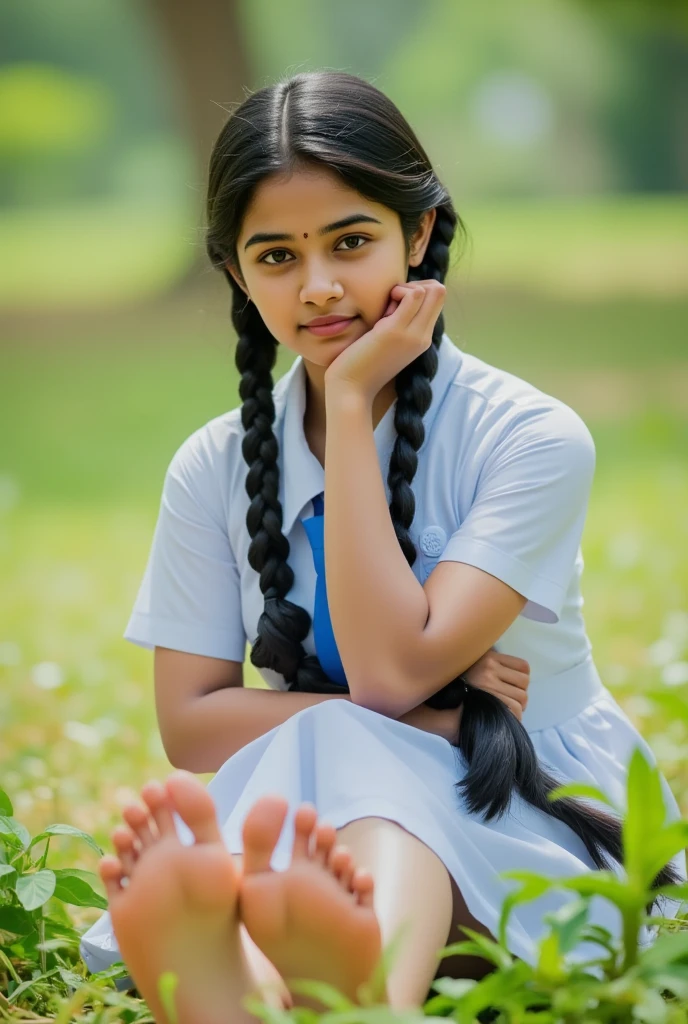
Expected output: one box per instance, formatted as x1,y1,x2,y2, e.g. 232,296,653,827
0,0,688,922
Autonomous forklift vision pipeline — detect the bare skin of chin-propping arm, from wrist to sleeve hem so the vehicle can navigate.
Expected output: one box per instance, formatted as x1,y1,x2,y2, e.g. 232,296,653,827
325,382,526,717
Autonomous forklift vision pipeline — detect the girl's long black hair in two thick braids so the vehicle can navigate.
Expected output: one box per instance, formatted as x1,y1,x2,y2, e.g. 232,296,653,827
207,72,682,912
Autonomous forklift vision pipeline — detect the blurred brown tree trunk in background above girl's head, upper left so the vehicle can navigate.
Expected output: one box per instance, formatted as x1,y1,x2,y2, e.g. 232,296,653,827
148,0,251,288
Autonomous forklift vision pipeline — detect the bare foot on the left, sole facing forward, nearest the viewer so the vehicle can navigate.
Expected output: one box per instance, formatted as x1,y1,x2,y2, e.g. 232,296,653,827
98,770,270,1024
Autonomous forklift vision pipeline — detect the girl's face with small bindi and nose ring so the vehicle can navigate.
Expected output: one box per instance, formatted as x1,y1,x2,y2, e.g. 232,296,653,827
227,159,435,369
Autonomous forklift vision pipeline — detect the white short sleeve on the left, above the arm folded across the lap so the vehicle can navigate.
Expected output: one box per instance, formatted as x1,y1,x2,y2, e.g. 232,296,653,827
124,435,246,662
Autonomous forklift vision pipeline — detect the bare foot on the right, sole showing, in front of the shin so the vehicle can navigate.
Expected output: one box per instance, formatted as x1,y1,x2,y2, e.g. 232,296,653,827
240,797,384,1009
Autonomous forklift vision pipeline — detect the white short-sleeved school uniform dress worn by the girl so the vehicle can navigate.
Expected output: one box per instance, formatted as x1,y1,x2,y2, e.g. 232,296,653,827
81,335,686,971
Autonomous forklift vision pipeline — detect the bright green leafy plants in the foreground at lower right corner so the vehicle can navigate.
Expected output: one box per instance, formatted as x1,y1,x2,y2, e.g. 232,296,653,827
241,748,688,1024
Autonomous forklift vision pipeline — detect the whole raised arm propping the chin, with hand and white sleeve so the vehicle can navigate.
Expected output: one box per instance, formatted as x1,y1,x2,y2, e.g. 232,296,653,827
325,281,595,718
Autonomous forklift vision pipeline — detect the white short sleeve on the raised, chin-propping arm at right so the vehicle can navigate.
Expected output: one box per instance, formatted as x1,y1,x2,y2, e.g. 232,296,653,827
439,403,595,623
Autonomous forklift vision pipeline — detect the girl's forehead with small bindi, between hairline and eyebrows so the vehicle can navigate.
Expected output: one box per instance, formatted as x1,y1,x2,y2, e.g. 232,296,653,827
241,168,394,238
